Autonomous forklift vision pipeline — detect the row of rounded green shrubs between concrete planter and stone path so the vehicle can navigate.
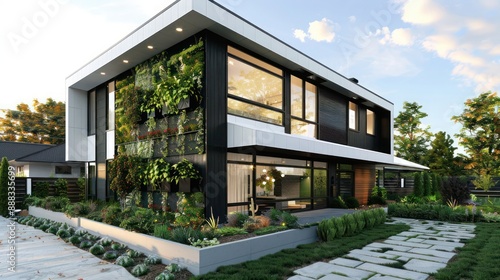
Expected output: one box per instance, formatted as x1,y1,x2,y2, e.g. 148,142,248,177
318,208,387,241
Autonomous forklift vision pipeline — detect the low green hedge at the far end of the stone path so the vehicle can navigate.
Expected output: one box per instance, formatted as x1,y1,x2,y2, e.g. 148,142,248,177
388,203,483,222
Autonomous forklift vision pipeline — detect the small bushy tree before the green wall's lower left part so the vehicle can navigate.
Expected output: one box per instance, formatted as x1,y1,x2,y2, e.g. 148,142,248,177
109,154,142,209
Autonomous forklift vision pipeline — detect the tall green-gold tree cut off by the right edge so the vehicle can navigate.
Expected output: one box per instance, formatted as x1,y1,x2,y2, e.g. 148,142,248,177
452,92,500,176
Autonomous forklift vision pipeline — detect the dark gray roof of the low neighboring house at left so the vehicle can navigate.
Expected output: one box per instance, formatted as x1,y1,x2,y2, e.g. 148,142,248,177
0,141,66,163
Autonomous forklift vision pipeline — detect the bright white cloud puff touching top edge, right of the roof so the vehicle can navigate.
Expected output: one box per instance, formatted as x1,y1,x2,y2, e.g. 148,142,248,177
402,0,446,25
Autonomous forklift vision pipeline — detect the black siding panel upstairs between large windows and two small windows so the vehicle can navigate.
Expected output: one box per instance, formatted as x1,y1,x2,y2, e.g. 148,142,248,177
318,87,348,145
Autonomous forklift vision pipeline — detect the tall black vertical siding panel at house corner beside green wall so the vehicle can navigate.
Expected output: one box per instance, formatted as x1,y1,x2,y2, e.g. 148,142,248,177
204,32,227,222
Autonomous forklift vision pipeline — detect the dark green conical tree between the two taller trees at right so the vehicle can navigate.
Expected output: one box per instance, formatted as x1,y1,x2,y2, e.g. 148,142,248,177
426,131,461,176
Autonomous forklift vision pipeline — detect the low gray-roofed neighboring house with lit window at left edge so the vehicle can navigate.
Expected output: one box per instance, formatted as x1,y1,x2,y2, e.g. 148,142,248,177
0,141,85,178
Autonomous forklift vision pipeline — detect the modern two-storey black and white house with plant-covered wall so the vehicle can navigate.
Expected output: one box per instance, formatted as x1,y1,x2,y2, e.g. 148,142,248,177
66,0,427,219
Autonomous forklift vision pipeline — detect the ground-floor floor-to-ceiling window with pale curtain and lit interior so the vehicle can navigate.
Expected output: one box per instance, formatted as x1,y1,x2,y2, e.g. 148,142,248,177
227,153,328,213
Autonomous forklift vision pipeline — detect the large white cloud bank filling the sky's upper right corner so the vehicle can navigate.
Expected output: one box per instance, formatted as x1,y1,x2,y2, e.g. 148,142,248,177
401,0,500,91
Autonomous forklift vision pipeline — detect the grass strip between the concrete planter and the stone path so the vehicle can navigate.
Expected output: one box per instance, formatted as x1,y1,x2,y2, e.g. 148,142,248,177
191,224,410,280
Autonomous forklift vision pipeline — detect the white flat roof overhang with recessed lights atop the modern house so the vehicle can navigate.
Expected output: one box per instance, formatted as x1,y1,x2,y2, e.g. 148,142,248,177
66,0,393,112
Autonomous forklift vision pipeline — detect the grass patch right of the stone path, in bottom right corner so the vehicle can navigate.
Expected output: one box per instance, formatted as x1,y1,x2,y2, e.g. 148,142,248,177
434,223,500,280
